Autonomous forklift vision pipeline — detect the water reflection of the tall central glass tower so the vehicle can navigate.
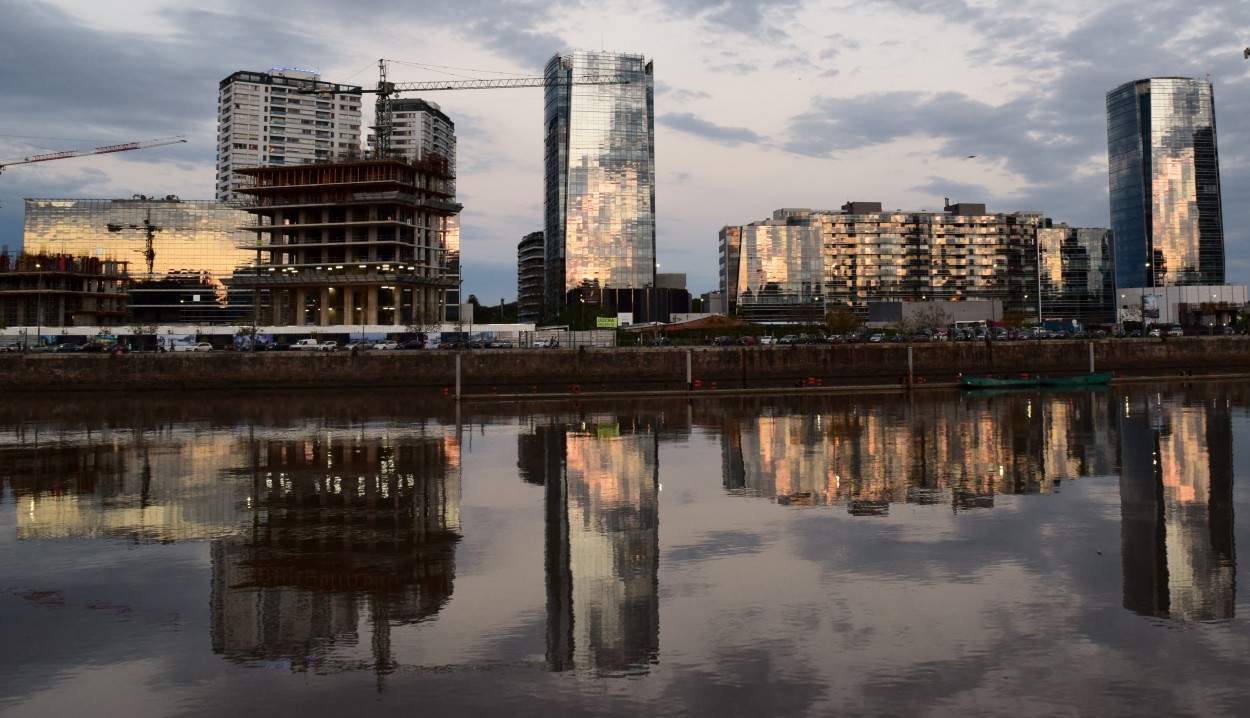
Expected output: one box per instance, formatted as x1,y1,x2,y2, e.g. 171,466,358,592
519,415,660,674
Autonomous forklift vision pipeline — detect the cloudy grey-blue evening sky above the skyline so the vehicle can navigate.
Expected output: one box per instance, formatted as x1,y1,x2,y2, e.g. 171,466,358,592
0,0,1250,304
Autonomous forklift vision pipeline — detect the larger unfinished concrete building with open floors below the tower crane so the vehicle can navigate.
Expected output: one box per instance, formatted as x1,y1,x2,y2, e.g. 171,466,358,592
234,154,461,326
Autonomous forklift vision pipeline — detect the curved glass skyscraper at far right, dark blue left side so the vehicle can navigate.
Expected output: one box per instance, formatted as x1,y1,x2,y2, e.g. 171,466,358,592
1106,78,1224,286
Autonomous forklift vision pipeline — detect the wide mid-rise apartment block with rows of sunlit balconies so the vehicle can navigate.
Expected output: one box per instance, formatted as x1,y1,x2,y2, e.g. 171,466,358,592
720,201,1046,323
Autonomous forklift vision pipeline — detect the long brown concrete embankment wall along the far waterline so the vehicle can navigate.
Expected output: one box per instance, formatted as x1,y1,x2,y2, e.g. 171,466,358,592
0,336,1250,395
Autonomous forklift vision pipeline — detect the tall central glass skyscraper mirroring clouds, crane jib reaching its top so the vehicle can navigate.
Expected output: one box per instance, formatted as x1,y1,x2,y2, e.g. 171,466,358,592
544,51,655,308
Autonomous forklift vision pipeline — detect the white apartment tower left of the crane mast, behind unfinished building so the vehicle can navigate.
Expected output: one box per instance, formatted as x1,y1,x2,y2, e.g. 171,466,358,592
216,69,360,201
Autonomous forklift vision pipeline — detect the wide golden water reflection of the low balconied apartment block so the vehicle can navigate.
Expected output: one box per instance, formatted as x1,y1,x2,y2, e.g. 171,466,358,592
723,393,1115,515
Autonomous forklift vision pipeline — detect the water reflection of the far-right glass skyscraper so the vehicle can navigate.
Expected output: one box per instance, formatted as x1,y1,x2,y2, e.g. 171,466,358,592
1120,394,1236,620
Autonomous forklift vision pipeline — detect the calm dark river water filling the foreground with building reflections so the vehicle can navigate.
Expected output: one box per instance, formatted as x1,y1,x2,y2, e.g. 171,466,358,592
0,383,1250,718
